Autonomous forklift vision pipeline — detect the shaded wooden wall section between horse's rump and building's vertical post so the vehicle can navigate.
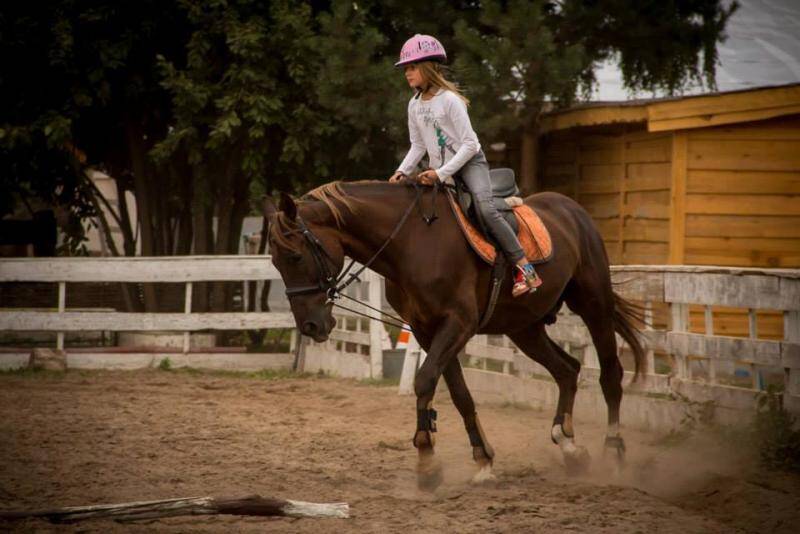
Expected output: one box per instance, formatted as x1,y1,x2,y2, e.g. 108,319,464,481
541,126,672,264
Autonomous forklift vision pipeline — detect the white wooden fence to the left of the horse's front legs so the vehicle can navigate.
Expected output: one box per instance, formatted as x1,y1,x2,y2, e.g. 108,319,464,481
0,255,384,377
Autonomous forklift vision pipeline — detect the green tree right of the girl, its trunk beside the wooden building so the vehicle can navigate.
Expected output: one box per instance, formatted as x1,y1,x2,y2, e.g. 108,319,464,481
455,0,736,192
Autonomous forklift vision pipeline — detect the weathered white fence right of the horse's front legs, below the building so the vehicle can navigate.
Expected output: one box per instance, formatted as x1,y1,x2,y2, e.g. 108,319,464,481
456,265,800,414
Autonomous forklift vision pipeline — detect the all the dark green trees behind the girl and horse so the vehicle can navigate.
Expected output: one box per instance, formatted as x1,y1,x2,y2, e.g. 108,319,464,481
0,0,735,307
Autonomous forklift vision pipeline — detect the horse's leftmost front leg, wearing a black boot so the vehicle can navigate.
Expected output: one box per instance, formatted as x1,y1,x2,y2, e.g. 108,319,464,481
414,316,474,490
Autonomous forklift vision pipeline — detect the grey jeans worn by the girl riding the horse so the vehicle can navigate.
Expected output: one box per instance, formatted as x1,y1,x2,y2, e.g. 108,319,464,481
457,151,525,263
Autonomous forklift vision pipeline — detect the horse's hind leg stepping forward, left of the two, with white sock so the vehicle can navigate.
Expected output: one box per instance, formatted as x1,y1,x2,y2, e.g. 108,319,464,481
509,323,589,472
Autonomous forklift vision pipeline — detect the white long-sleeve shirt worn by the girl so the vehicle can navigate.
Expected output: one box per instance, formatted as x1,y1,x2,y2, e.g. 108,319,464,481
397,89,481,180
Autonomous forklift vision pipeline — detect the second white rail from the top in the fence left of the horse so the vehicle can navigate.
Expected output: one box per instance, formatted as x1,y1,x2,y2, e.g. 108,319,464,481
0,311,295,332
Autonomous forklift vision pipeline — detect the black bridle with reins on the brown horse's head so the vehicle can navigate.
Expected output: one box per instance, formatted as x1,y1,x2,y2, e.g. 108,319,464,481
278,183,435,327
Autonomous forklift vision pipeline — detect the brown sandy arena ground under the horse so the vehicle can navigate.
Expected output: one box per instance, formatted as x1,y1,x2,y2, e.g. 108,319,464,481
0,370,800,534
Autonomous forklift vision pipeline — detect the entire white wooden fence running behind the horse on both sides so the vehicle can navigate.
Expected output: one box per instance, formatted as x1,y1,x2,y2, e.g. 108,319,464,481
0,256,800,413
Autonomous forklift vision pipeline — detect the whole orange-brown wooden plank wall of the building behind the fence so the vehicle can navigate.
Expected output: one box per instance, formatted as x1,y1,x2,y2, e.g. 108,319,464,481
540,115,800,339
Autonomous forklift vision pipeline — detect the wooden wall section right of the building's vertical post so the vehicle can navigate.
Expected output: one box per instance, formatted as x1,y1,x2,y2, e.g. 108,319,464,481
673,115,800,267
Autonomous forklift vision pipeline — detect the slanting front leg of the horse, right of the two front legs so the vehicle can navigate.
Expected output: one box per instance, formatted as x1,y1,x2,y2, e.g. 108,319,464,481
443,357,495,483
